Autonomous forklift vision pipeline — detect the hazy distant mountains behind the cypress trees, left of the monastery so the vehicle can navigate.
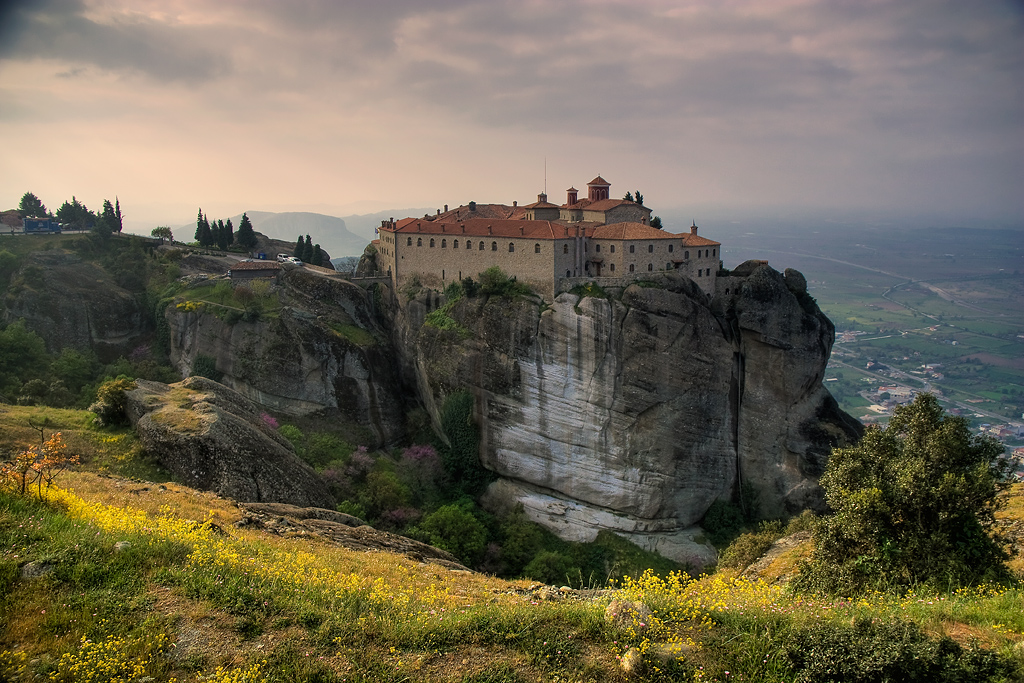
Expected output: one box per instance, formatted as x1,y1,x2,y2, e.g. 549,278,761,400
174,209,431,258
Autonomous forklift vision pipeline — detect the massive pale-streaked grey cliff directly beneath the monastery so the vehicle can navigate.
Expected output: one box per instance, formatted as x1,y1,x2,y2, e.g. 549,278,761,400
397,264,859,564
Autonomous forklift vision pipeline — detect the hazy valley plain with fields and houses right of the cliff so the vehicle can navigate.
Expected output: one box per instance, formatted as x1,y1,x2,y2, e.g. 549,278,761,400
720,225,1024,444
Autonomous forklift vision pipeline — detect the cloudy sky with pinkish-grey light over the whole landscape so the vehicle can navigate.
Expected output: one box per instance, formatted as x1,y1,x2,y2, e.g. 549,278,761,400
0,0,1024,231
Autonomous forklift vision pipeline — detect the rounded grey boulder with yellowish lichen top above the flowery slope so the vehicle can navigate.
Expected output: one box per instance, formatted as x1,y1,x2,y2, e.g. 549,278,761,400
126,377,335,508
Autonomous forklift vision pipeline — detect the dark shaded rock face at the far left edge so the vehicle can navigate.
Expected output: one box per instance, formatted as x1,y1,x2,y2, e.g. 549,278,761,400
6,250,152,358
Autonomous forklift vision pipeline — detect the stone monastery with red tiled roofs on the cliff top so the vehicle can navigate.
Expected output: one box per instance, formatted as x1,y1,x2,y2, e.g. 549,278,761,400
373,176,722,299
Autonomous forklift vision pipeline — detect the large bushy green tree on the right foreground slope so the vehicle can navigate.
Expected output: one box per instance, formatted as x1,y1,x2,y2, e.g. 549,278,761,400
798,394,1015,594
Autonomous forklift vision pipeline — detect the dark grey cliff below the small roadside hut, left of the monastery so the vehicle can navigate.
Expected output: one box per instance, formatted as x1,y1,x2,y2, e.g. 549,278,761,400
165,268,408,445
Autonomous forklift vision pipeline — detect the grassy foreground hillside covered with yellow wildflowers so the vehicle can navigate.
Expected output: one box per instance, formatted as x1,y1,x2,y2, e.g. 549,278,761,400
0,407,1024,682
